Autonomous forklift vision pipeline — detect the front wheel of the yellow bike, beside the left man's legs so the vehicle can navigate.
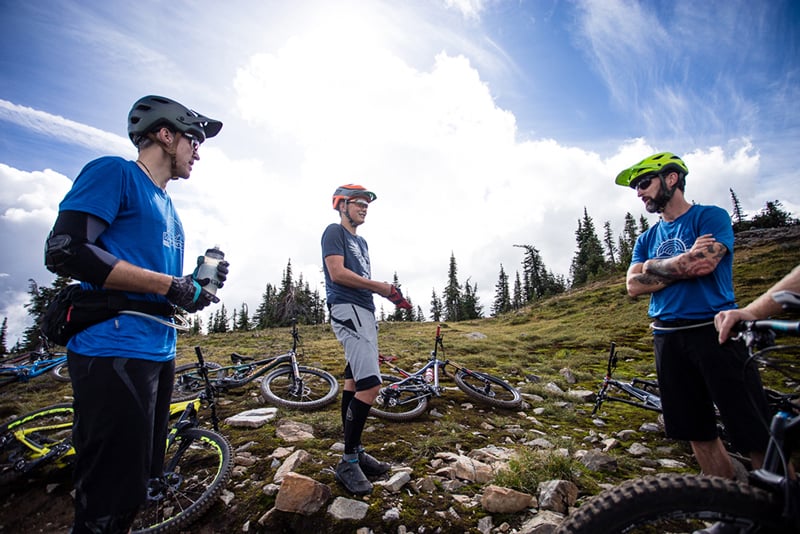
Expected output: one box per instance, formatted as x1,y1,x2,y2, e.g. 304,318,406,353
132,428,232,534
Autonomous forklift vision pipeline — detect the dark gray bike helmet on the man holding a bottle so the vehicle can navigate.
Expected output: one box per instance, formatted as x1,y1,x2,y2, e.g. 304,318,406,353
128,95,222,146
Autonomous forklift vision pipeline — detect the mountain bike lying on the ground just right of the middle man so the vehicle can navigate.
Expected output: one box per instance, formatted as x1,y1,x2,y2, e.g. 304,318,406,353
370,325,522,421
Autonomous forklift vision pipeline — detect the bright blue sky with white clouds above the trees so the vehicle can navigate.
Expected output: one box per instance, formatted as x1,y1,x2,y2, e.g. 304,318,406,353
0,0,800,347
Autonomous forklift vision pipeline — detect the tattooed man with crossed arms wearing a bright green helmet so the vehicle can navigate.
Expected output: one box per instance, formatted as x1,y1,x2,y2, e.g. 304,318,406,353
616,152,768,498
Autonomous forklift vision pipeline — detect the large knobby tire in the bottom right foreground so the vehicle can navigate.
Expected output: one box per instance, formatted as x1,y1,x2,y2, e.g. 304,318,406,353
556,474,794,534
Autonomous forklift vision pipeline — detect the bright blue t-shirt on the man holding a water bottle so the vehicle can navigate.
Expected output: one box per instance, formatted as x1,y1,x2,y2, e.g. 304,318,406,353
59,156,184,361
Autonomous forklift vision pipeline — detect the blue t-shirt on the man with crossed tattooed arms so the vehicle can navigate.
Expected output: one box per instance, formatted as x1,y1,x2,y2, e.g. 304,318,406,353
631,205,736,321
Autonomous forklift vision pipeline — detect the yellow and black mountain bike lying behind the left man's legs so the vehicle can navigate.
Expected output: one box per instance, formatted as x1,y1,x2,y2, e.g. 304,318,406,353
0,349,233,533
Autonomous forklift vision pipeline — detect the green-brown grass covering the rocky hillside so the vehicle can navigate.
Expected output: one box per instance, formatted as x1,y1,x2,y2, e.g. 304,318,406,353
0,227,800,533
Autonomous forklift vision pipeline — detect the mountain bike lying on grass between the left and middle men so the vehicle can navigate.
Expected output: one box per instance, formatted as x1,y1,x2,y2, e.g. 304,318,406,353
172,321,339,410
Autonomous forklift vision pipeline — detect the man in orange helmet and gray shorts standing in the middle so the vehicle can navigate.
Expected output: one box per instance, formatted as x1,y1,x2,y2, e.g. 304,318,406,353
322,184,411,495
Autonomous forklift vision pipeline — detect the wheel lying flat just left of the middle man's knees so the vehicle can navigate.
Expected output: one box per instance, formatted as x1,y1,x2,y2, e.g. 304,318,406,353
261,365,339,410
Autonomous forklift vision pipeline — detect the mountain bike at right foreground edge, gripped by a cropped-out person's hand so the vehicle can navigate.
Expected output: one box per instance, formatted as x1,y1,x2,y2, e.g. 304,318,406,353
556,292,800,534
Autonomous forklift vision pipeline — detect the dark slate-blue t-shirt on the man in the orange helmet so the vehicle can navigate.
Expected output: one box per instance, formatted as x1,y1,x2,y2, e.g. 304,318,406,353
322,223,375,313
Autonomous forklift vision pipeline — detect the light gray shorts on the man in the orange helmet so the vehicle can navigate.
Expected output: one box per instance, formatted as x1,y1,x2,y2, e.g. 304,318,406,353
330,304,381,391
